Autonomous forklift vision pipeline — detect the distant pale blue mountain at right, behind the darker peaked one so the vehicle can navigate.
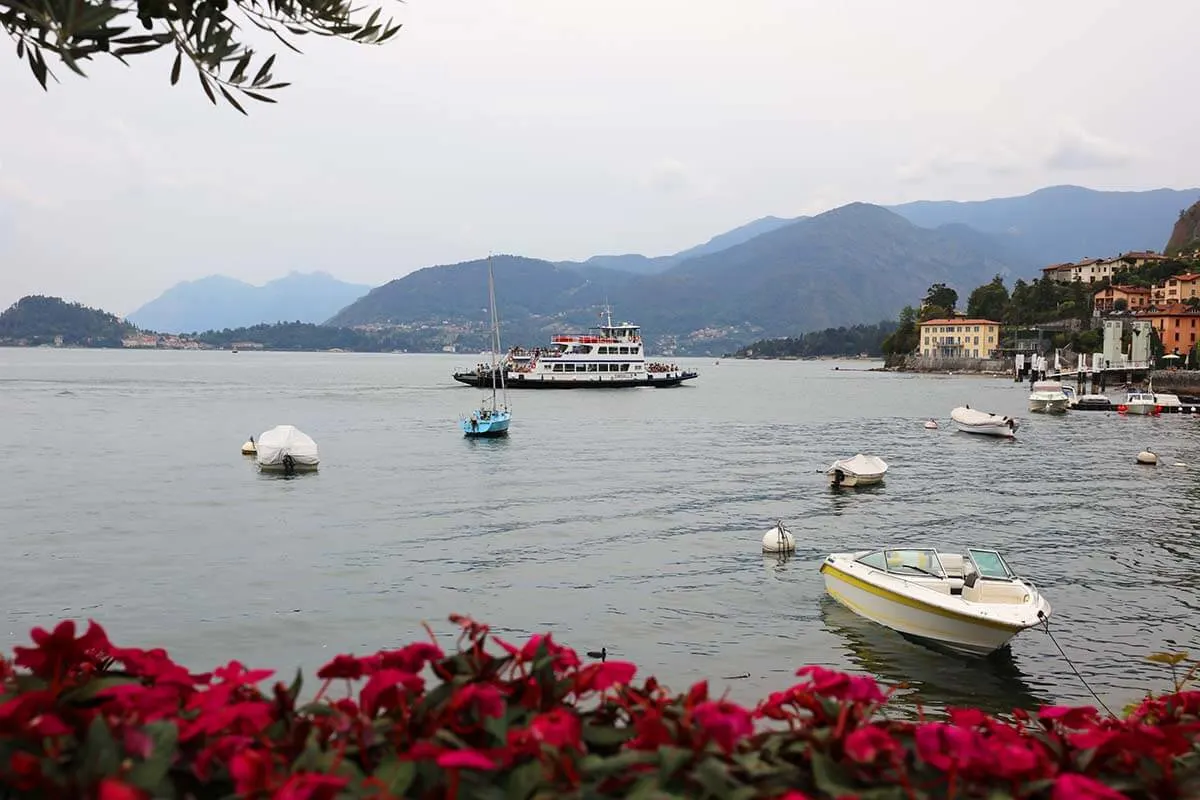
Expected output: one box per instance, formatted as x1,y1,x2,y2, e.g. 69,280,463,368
887,186,1200,266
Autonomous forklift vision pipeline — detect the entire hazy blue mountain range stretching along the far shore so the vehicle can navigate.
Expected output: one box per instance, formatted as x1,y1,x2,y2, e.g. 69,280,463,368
130,186,1200,354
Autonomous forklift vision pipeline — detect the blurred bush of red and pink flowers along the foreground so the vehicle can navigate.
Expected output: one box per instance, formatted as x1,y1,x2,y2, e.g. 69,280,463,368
0,616,1200,800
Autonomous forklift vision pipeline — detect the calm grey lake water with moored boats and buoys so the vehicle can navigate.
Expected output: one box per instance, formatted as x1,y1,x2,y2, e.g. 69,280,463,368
0,349,1200,710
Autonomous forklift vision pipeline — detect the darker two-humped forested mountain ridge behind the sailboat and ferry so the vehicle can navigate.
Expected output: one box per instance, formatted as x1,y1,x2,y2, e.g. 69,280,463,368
330,203,1032,353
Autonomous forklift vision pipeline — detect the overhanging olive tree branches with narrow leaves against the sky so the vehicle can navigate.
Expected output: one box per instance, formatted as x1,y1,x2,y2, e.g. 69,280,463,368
0,0,400,114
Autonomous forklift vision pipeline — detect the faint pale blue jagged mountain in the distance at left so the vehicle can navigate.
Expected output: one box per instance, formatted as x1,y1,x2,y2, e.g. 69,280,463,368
127,272,371,333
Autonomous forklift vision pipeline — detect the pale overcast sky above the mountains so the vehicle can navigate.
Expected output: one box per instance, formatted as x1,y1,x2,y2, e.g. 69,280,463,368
0,0,1200,314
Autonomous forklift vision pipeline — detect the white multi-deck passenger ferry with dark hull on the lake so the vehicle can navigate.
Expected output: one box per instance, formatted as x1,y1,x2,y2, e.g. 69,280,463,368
454,312,698,389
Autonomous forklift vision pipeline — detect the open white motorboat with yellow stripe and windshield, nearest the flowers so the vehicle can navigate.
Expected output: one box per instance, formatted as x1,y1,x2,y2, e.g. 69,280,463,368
821,547,1051,656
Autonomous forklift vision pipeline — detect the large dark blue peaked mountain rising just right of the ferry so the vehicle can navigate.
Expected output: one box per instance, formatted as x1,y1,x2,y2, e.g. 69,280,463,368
609,203,1032,342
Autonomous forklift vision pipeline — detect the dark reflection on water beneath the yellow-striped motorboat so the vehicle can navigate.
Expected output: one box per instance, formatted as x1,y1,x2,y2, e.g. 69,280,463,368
821,595,1049,715
